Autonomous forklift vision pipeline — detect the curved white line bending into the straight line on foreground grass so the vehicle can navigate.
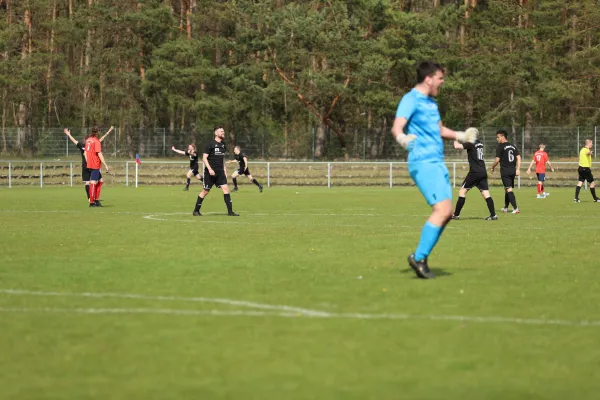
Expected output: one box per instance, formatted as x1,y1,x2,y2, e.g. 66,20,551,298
0,289,327,315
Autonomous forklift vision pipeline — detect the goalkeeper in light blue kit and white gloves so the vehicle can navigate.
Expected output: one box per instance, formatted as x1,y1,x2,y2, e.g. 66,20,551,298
392,61,479,279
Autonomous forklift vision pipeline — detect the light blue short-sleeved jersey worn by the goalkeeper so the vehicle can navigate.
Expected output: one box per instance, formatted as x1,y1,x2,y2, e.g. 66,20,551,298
396,88,444,163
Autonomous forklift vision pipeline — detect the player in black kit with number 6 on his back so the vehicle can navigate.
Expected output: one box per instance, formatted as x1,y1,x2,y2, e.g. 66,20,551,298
490,130,521,214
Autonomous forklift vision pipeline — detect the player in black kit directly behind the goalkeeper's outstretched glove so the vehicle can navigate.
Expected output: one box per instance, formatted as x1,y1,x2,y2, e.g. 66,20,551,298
452,140,498,221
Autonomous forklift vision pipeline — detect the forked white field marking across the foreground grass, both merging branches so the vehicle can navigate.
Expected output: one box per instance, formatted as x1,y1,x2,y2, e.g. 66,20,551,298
0,289,600,327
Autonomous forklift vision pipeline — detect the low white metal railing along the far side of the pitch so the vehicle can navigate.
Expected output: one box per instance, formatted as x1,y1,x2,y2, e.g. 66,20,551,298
0,160,578,188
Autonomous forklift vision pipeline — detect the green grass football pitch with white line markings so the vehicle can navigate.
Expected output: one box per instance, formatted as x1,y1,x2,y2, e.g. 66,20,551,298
0,185,600,399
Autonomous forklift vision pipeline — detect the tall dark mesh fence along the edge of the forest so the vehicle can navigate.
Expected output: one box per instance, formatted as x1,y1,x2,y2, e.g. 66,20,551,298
0,126,598,161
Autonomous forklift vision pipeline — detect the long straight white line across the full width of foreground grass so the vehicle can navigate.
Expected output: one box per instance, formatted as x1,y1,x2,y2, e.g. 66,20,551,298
0,307,600,327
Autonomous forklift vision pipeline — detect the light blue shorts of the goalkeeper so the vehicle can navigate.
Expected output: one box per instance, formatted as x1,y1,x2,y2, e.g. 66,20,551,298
408,162,452,206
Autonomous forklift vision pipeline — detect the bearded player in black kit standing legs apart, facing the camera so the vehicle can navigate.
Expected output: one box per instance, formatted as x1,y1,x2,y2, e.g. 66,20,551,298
192,125,239,217
